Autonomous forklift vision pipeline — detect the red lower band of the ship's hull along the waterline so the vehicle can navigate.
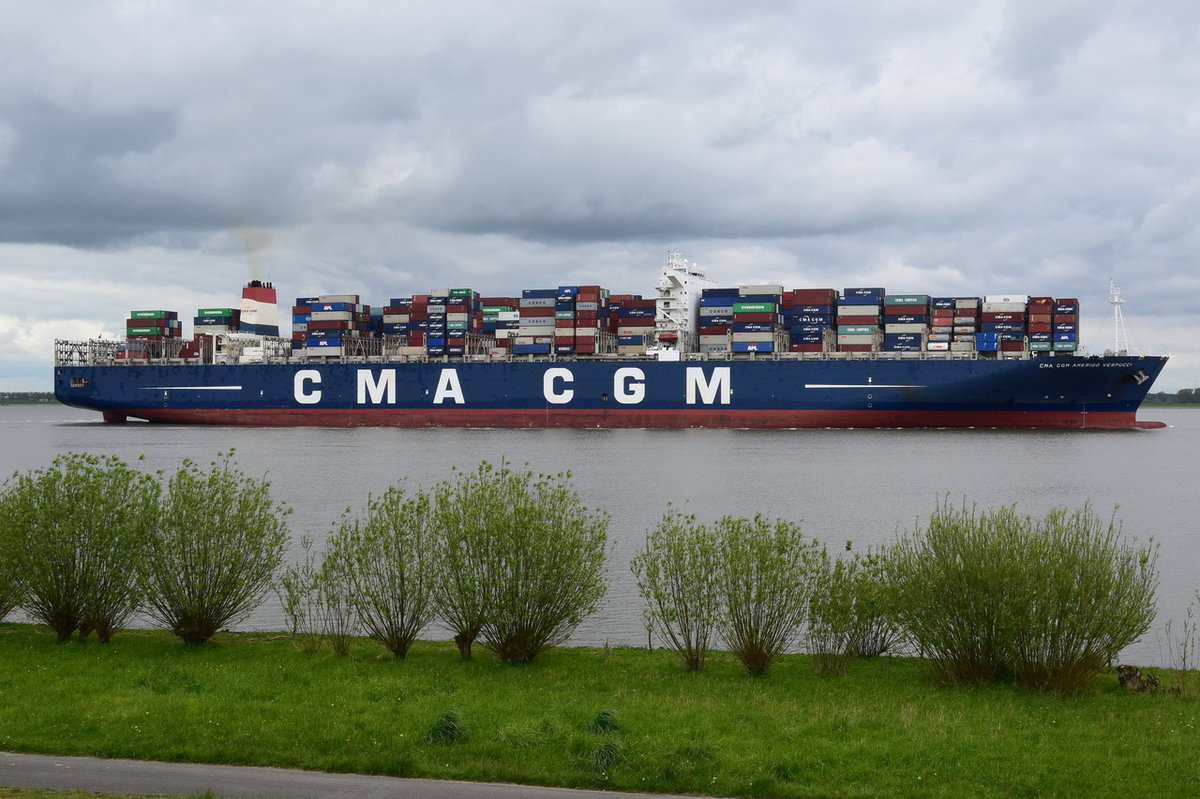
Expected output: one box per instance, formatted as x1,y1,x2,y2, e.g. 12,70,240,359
104,408,1165,429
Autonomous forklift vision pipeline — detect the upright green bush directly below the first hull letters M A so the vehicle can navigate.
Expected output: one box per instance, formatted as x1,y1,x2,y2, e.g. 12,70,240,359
325,486,438,657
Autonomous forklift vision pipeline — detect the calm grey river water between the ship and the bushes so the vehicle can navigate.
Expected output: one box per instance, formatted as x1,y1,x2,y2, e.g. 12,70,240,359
0,405,1200,665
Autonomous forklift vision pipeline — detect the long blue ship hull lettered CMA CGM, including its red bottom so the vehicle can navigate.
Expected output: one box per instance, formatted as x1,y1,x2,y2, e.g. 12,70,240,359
55,354,1166,428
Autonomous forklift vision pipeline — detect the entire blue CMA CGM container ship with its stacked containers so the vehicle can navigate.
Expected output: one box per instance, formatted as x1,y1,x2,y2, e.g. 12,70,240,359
54,252,1166,428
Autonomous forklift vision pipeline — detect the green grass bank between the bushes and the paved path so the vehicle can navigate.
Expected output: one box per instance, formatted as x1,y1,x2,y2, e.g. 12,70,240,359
0,624,1200,797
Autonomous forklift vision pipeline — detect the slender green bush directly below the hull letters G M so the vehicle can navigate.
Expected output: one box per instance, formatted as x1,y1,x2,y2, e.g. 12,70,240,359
630,509,720,672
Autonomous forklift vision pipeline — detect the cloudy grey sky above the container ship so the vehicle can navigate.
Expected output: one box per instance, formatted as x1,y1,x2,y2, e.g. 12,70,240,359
0,0,1200,391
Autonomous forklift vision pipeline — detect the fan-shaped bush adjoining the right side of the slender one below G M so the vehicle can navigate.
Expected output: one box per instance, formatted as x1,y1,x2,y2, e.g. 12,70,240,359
716,516,827,674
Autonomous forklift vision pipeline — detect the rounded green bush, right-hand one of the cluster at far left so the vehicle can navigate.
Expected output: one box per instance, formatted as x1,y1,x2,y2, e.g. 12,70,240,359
143,451,289,644
